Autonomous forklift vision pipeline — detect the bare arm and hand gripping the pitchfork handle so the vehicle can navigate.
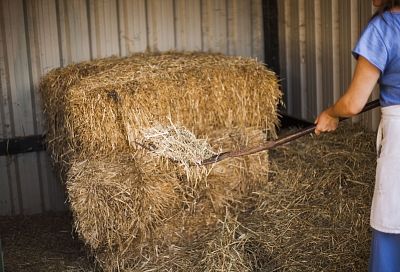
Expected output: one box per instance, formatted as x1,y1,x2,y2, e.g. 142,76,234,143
315,56,380,135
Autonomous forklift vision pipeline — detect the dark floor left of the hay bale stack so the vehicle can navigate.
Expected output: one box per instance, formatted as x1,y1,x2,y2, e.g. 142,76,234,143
0,213,96,272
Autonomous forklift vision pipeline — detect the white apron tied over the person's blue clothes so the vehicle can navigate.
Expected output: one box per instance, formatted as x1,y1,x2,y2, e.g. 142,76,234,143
371,105,400,233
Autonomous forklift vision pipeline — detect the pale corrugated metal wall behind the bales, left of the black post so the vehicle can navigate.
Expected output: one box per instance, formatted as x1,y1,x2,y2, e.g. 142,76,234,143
0,0,264,215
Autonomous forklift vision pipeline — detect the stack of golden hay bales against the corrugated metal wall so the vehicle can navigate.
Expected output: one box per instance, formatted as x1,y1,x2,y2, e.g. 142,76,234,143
40,53,281,271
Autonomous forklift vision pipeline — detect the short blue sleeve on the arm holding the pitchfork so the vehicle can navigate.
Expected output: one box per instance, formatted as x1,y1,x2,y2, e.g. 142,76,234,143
352,23,388,73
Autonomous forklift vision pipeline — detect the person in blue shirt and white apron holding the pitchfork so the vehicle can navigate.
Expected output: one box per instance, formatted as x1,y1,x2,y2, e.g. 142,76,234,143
315,0,400,272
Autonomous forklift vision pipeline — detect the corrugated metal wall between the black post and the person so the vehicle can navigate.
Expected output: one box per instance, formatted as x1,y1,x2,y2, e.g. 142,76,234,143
278,0,379,128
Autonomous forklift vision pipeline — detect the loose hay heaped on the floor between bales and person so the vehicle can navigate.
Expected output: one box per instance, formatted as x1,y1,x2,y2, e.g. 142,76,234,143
127,126,376,272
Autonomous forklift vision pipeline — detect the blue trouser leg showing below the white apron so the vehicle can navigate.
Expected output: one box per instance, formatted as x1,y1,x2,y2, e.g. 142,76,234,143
369,229,400,272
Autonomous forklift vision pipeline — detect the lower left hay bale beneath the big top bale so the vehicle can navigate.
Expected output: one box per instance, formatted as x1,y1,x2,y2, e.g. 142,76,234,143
67,152,179,250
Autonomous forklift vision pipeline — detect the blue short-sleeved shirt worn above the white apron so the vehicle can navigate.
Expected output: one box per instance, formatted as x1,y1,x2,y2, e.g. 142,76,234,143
353,11,400,107
